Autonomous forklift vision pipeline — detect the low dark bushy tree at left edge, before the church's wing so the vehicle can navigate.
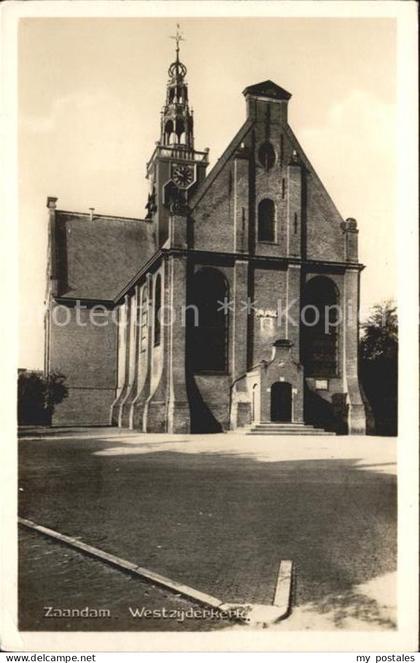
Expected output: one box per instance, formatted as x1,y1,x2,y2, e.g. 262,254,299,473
18,371,68,425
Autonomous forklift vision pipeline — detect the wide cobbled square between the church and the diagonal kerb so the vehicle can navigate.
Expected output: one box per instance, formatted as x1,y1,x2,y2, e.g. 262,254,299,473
20,432,396,622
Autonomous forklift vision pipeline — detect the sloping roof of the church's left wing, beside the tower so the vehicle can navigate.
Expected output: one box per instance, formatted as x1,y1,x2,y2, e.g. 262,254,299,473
53,210,155,301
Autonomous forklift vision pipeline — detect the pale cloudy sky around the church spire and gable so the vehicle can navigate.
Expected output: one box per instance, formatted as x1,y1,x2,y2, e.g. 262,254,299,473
18,16,397,368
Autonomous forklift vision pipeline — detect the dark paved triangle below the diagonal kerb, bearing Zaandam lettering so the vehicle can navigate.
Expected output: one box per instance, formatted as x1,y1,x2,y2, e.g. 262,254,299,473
19,528,233,631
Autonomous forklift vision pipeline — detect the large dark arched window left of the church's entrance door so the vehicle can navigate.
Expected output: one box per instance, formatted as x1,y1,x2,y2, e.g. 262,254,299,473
188,269,229,373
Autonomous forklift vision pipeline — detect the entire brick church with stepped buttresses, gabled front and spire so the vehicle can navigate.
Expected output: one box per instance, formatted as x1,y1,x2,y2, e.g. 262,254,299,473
45,35,366,434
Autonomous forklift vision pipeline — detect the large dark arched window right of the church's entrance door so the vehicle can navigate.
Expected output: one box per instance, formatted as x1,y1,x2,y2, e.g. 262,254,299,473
301,276,339,378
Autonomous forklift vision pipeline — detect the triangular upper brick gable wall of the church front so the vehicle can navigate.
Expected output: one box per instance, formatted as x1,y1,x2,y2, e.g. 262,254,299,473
193,100,345,268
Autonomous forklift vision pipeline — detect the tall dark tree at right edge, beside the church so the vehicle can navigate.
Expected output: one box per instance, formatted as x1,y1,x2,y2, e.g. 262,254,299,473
360,301,398,435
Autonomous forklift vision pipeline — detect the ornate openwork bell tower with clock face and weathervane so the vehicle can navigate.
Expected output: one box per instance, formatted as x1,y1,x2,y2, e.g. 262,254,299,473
146,25,209,246
